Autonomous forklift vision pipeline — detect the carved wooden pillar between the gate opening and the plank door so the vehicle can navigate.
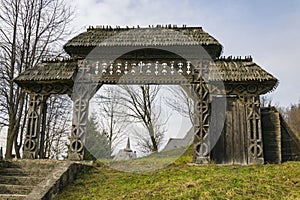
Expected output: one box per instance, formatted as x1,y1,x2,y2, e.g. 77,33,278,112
192,61,210,164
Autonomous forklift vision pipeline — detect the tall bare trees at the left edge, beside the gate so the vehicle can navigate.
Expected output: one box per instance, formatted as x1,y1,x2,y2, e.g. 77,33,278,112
0,0,73,159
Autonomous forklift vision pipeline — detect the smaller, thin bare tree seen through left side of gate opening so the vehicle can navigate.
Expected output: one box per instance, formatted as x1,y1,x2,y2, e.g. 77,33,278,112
95,86,129,153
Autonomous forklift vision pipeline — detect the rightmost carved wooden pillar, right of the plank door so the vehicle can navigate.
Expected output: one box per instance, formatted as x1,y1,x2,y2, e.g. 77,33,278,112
243,96,264,164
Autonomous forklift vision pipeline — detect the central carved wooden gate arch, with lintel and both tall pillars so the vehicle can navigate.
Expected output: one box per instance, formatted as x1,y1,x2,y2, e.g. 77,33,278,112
69,41,225,163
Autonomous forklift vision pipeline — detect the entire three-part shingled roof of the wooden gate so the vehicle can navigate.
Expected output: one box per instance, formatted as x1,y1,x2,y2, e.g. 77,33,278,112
15,25,278,94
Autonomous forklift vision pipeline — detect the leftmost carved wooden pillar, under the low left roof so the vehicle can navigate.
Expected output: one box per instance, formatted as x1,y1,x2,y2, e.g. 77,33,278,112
23,94,48,159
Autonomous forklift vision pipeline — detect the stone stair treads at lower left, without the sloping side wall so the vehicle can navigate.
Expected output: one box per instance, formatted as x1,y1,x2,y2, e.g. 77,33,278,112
0,160,58,200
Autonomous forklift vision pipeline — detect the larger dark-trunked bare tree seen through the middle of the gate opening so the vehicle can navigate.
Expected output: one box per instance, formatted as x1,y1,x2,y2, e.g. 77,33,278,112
121,85,168,152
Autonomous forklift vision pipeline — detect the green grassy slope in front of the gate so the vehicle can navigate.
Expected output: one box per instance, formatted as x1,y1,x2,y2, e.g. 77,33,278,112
55,148,300,200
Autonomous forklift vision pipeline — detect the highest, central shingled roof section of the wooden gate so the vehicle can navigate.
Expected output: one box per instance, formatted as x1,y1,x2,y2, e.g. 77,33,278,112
64,26,222,58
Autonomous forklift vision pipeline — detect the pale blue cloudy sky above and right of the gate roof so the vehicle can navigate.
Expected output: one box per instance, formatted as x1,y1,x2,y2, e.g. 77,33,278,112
67,0,300,106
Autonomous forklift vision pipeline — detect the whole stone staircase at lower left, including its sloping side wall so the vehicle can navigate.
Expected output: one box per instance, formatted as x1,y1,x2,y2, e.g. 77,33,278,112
0,160,91,200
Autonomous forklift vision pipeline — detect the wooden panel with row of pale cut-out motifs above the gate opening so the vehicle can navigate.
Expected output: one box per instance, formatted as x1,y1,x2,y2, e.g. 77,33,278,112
82,60,193,84
